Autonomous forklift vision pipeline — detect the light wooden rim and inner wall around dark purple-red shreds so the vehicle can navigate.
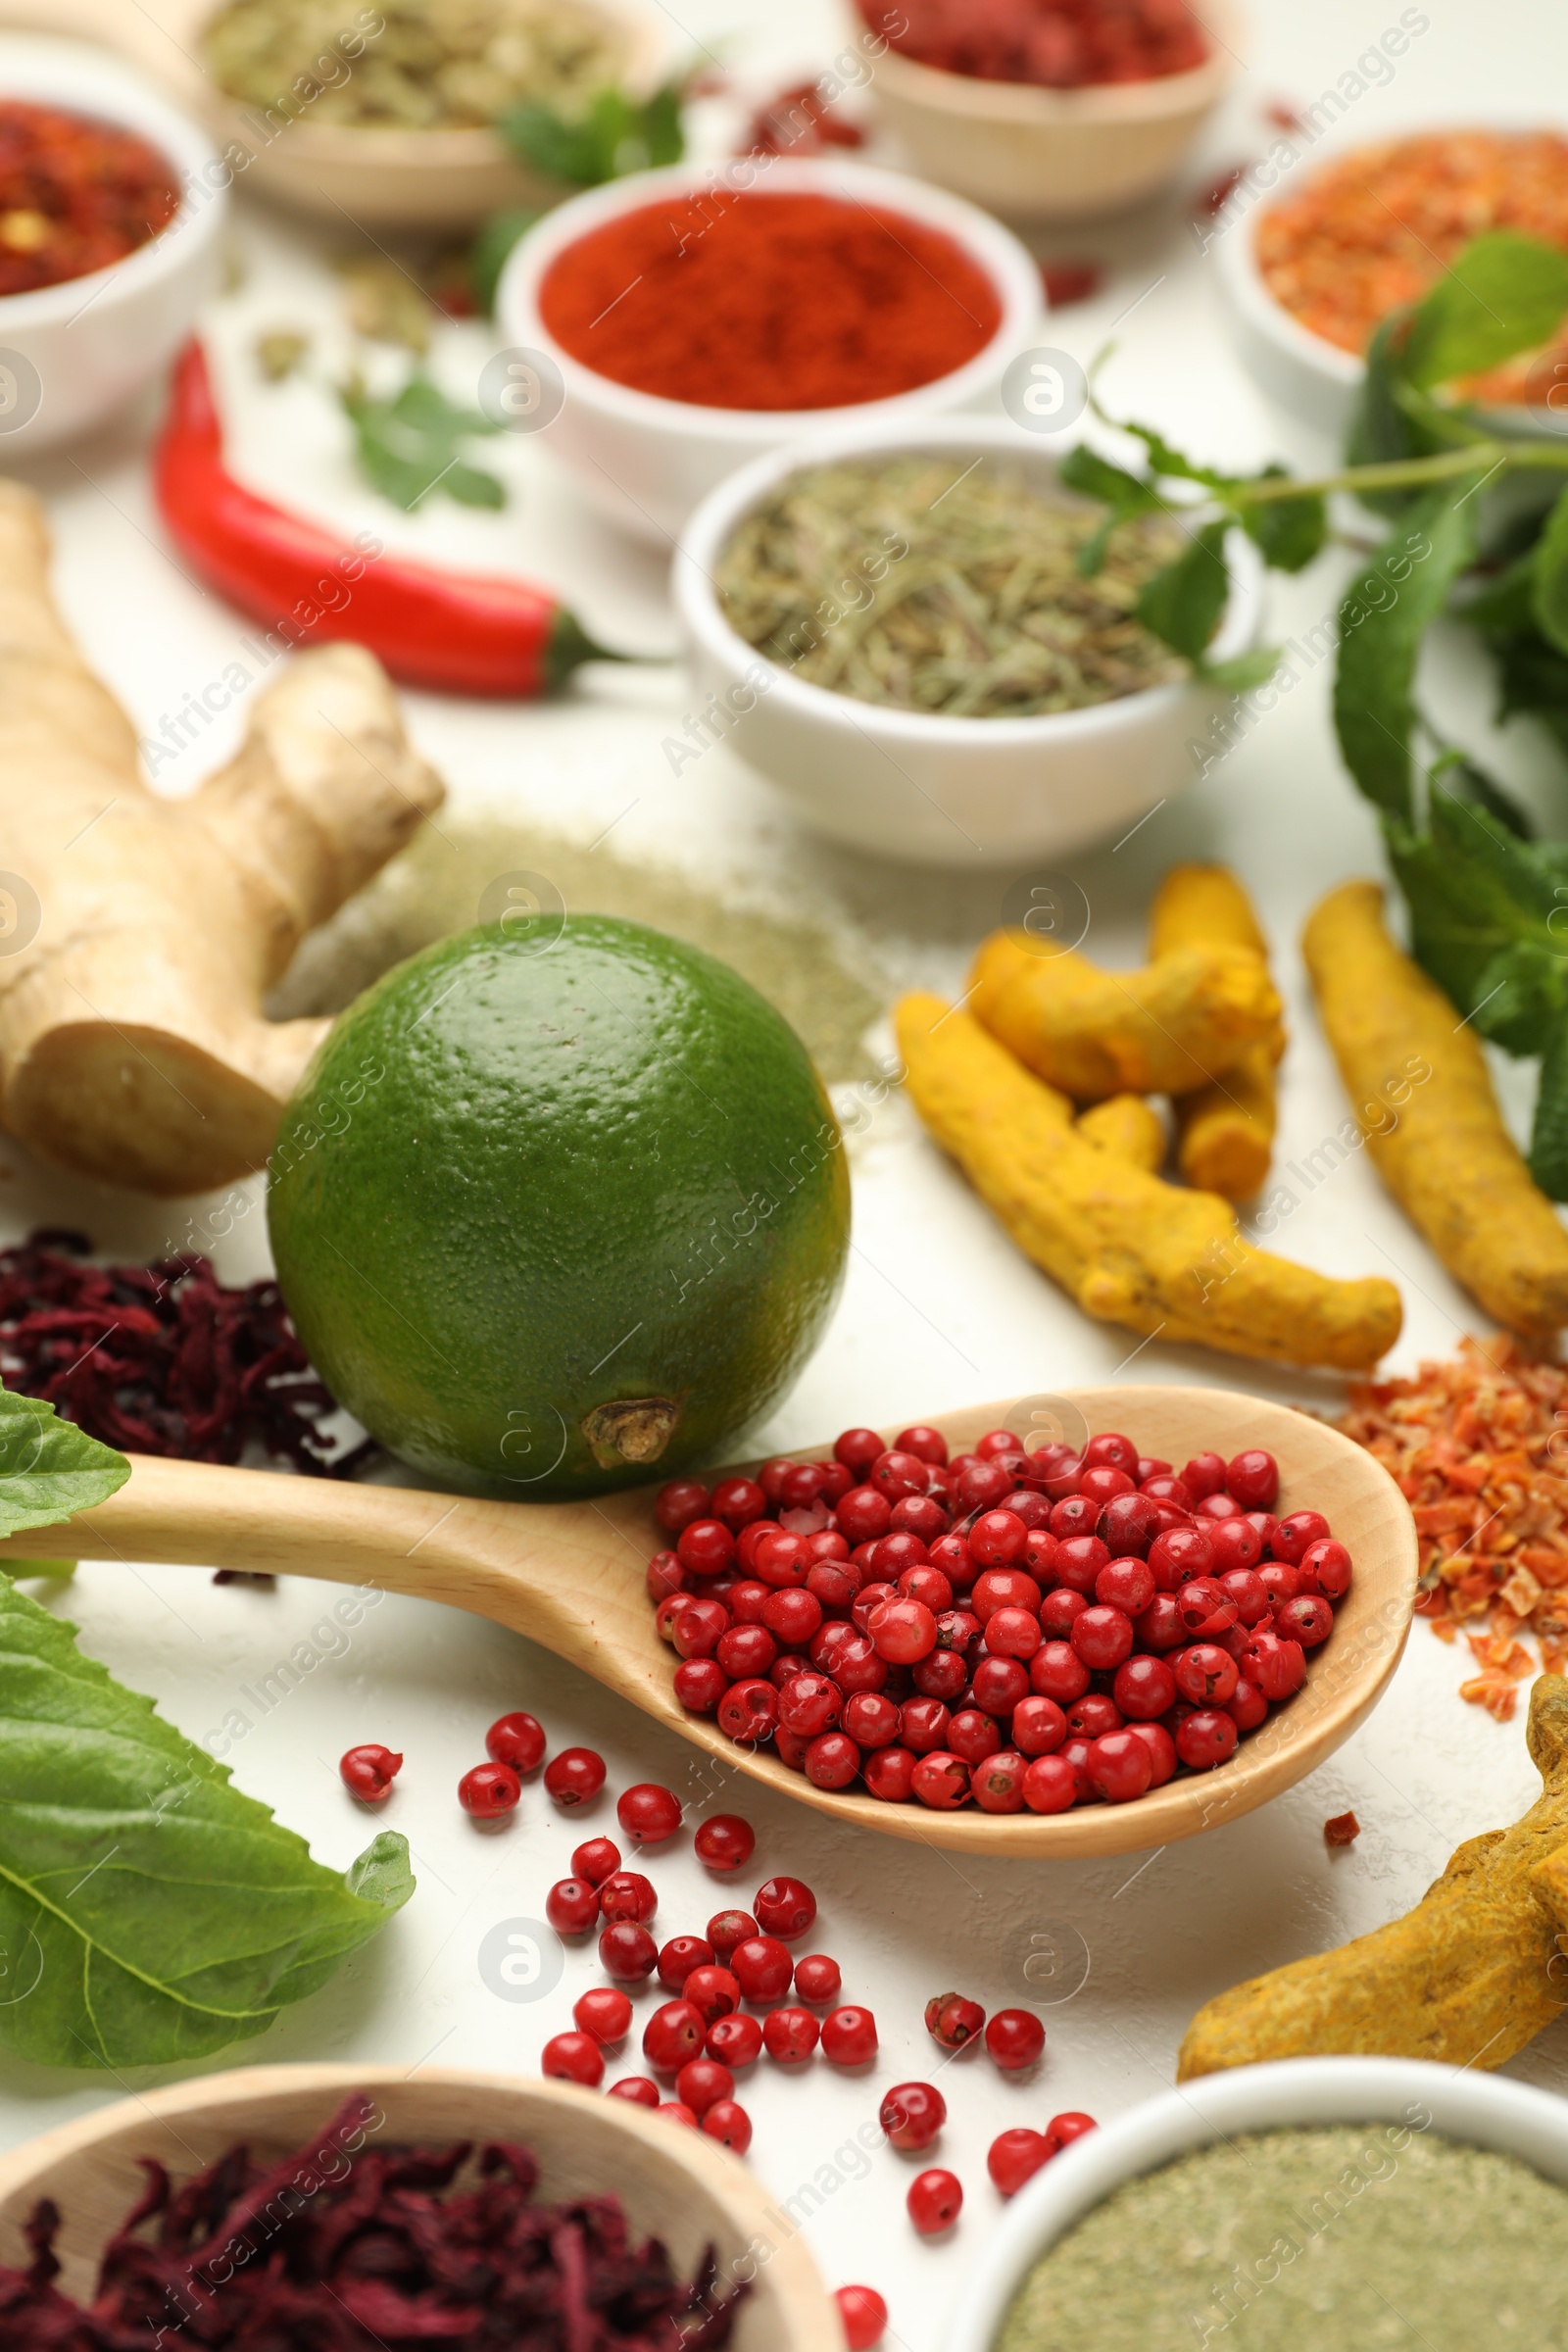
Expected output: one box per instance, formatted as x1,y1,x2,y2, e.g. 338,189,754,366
0,2065,842,2352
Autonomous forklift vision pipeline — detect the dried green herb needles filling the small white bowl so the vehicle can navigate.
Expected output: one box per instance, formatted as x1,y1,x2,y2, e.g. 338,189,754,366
717,452,1187,719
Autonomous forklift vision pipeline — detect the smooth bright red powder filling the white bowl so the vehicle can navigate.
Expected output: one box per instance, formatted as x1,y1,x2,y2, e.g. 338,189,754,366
538,190,1002,410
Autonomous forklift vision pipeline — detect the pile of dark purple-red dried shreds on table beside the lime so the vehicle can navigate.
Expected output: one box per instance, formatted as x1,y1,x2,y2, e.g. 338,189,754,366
0,1228,376,1477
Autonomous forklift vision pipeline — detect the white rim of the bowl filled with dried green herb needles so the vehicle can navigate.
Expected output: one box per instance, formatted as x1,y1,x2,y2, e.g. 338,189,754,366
674,416,1262,748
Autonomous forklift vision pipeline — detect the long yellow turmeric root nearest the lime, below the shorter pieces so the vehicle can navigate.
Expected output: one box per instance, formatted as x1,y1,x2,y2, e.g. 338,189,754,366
896,995,1401,1371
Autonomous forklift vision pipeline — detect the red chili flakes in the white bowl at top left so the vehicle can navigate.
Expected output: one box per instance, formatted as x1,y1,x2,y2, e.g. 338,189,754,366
0,99,178,294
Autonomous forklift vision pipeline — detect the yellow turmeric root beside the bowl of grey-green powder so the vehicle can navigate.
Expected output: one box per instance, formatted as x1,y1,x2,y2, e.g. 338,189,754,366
1175,1675,1568,2082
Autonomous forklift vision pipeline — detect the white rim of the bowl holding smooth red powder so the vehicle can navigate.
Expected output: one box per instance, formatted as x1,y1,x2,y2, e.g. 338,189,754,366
496,155,1046,447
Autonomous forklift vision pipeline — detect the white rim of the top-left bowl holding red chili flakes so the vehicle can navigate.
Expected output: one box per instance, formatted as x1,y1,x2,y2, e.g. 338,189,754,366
0,30,223,336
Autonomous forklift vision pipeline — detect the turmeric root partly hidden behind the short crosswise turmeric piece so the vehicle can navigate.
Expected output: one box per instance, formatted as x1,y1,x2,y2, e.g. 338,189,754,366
1150,865,1286,1200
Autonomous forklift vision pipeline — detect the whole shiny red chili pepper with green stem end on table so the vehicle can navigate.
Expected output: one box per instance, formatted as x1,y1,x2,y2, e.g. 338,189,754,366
153,341,625,696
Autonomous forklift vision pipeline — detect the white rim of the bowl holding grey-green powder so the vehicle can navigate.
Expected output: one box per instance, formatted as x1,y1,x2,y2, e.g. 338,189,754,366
948,2058,1568,2352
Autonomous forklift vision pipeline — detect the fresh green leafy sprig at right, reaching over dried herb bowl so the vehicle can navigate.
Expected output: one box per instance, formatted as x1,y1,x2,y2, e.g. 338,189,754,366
1091,233,1568,1200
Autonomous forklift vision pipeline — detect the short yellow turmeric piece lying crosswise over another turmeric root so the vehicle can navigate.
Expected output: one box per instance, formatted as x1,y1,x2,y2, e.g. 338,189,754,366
966,931,1279,1103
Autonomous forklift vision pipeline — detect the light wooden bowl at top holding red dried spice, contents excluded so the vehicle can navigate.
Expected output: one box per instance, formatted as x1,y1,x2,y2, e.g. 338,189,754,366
872,0,1242,221
